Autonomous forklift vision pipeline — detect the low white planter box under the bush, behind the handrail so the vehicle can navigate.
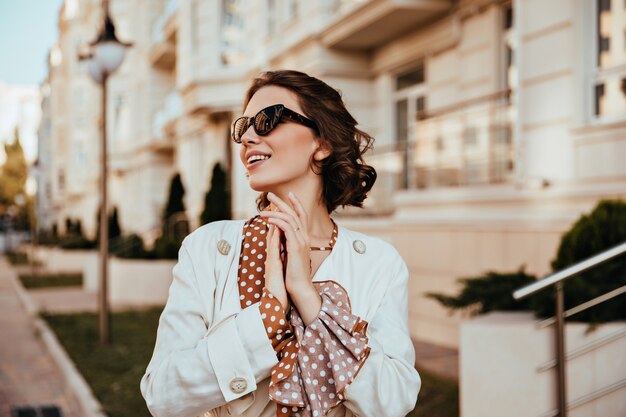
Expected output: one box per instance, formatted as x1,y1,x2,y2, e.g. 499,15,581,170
459,312,626,417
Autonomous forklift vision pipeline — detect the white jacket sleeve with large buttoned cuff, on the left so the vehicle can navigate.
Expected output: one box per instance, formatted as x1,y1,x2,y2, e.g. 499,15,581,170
141,242,278,417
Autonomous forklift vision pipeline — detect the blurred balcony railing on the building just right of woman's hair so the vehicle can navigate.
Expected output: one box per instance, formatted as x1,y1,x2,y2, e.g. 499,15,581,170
368,91,515,189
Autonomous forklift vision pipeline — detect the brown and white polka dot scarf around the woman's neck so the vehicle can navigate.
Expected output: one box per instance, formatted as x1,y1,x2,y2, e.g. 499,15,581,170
239,216,370,417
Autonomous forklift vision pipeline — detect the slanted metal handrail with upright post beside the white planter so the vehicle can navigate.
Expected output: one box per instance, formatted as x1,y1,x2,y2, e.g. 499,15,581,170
513,242,626,417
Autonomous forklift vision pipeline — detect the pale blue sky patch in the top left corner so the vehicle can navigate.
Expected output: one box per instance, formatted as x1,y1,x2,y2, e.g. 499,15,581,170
0,0,63,85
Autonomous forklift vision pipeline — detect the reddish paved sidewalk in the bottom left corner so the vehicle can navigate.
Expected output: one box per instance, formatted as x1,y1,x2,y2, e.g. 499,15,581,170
0,257,80,417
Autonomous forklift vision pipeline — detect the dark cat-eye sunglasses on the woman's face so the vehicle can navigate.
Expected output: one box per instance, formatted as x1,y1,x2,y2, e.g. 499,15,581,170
231,104,318,143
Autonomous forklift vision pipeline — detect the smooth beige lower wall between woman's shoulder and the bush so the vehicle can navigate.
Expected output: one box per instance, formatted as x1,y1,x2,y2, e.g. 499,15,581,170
336,180,626,347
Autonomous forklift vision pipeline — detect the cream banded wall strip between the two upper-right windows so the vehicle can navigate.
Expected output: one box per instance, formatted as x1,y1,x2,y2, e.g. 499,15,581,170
517,0,572,181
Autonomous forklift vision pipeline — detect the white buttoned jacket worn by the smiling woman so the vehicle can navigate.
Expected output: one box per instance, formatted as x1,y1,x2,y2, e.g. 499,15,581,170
141,220,421,417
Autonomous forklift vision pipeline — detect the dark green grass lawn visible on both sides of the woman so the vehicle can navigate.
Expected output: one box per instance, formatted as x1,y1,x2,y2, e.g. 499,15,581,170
43,309,459,417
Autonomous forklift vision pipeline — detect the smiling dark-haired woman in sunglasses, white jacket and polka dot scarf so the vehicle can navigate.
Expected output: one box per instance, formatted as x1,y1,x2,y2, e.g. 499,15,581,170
141,71,421,417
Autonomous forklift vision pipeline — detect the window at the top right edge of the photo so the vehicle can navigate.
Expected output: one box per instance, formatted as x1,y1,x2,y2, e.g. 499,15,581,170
591,0,626,121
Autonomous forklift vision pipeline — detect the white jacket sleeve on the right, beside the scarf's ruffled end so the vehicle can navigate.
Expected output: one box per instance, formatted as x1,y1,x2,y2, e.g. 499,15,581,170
344,254,421,417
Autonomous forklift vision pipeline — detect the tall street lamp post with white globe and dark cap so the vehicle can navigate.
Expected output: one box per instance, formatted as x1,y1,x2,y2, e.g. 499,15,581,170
79,0,131,344
